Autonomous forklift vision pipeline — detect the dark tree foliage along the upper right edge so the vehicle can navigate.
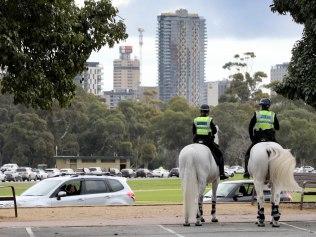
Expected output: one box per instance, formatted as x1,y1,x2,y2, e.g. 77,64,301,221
271,0,316,108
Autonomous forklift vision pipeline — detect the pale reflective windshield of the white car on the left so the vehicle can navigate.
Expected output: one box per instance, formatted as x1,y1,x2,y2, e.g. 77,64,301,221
21,179,63,196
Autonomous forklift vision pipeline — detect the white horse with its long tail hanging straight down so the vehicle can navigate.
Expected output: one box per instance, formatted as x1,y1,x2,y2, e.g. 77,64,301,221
179,143,219,226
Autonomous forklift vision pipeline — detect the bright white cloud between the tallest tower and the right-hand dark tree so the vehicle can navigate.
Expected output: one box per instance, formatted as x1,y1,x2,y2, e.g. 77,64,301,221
205,38,299,84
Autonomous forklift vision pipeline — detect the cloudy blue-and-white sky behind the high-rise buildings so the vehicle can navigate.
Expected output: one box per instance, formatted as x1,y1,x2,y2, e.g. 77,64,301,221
76,0,303,90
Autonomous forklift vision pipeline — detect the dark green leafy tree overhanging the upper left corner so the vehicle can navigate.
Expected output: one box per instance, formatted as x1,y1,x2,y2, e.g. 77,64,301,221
0,0,127,109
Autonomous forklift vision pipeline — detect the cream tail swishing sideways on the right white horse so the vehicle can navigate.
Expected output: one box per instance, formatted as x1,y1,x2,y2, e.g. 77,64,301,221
267,147,302,191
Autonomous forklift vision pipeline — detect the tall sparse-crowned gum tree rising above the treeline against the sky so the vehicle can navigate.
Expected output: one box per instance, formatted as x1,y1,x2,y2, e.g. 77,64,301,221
220,52,267,102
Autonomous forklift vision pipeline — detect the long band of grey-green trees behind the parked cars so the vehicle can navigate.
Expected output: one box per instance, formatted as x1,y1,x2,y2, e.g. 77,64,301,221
0,90,316,168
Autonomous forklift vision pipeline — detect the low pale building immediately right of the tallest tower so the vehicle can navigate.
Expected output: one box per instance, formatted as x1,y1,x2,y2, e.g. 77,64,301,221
205,80,230,106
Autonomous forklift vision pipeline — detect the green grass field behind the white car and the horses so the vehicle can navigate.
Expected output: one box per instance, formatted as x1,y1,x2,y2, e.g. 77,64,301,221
0,174,316,204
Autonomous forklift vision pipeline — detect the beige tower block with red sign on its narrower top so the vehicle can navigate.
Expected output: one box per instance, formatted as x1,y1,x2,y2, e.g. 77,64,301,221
113,46,140,91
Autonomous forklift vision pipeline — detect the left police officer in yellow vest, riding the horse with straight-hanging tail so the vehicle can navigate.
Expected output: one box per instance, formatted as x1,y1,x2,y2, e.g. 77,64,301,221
192,104,228,180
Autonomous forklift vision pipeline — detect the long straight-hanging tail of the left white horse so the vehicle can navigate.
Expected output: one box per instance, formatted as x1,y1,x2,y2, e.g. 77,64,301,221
179,149,198,222
